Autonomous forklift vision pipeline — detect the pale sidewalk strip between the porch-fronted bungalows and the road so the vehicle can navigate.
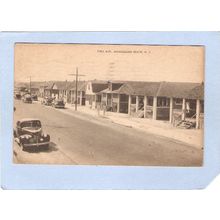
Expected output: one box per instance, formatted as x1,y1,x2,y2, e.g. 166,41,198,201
66,104,203,149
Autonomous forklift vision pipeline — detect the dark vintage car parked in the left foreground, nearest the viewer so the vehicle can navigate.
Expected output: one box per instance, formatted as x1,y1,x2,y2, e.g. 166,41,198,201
14,118,50,151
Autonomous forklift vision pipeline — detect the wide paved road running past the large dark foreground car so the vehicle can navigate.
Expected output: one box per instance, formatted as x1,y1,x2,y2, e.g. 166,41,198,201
13,100,203,166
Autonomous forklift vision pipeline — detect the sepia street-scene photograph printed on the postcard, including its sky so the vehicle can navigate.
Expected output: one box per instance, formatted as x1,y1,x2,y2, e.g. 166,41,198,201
13,43,205,167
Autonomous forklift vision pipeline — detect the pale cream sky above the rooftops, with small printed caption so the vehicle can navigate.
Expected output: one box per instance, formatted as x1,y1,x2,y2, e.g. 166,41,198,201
15,43,205,82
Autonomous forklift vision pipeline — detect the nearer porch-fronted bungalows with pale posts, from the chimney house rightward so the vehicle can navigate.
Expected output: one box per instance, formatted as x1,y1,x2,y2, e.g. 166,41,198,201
87,82,204,128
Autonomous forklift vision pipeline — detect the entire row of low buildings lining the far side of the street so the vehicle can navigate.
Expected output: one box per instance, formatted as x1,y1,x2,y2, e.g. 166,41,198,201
15,80,204,128
